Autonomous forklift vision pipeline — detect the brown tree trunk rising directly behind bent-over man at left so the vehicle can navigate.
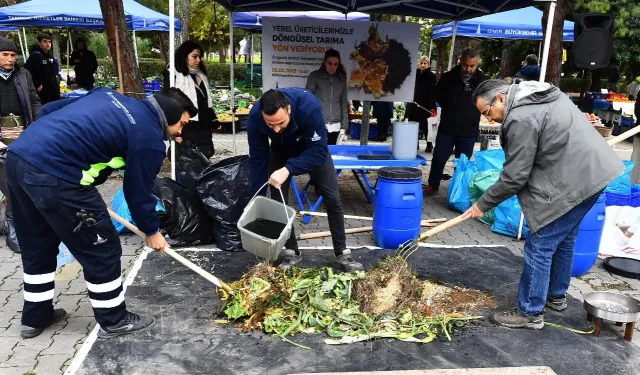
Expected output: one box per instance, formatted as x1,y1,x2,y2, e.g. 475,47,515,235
100,0,146,99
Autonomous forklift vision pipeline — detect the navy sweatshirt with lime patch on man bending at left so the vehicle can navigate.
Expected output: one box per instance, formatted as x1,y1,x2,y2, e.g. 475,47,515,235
9,87,167,235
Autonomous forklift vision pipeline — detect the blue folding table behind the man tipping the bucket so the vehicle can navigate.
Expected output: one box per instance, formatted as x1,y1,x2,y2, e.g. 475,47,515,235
291,146,427,224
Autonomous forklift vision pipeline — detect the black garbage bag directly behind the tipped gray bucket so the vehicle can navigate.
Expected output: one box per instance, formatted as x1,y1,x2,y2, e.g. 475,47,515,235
196,155,251,251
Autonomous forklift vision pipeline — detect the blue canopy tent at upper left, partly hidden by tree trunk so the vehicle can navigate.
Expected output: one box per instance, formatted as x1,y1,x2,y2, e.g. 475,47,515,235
0,0,180,65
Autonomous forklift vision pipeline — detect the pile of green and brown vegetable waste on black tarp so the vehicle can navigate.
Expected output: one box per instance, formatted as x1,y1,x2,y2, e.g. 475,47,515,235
222,257,495,349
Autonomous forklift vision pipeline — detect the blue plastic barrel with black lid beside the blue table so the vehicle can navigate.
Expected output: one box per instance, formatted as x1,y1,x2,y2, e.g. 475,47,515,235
373,167,422,249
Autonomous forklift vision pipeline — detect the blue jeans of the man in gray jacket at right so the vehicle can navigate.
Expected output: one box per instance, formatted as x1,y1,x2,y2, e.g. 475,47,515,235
518,193,600,316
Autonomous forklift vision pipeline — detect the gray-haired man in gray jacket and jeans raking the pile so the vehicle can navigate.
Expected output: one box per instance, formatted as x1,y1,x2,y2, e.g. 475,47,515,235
464,80,624,329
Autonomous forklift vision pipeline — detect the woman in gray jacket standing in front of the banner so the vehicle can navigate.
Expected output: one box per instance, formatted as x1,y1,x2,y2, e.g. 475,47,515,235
305,49,349,145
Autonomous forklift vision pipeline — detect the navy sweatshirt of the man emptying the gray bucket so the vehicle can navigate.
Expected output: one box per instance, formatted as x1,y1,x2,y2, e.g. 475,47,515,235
247,87,329,194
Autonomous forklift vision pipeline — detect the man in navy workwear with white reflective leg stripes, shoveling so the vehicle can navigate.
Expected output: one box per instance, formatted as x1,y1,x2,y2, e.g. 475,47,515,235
6,88,197,338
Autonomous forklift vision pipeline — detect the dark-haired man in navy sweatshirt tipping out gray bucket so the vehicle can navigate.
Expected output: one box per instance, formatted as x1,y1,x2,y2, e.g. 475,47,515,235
247,88,363,271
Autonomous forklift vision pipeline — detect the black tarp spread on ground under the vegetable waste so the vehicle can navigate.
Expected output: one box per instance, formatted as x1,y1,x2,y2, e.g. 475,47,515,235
79,247,640,375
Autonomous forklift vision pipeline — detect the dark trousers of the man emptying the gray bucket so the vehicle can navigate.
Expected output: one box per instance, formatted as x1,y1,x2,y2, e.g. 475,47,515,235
269,150,347,255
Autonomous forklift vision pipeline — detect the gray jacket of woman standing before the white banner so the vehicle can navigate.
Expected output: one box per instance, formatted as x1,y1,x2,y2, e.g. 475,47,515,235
305,68,349,130
